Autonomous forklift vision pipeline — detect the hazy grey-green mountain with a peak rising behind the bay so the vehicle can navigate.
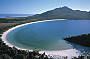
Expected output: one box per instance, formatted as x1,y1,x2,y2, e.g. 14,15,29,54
29,6,90,19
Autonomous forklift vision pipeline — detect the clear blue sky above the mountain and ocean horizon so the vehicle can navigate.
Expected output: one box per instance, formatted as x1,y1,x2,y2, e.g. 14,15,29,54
0,0,90,14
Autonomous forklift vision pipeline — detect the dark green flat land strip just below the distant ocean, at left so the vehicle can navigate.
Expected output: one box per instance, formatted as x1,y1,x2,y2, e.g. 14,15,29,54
0,17,40,23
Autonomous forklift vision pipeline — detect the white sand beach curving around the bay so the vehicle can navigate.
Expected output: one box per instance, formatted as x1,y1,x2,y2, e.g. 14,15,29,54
1,19,80,56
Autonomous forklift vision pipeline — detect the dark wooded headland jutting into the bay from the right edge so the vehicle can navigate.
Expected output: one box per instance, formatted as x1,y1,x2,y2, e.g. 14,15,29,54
64,34,90,47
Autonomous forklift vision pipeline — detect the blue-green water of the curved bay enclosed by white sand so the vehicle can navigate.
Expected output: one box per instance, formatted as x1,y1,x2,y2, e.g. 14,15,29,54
7,20,90,52
